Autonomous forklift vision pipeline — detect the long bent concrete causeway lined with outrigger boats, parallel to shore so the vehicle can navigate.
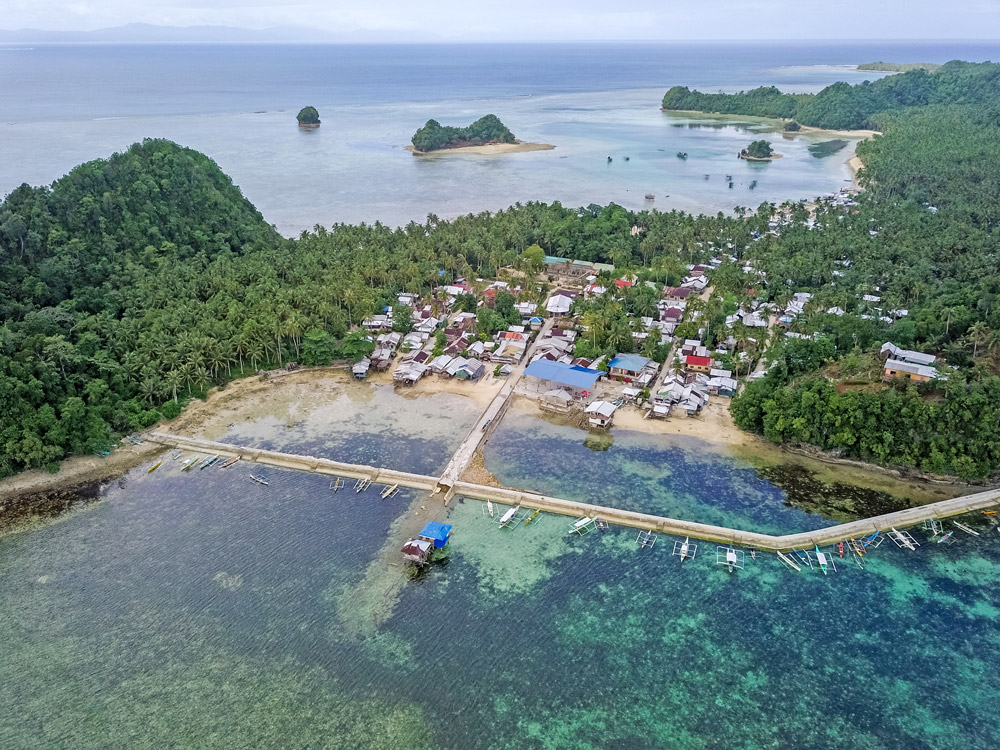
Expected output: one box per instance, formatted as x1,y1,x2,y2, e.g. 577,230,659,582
145,432,1000,551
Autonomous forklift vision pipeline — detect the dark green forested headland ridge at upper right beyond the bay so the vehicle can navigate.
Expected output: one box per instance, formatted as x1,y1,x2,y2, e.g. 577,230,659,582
662,61,1000,129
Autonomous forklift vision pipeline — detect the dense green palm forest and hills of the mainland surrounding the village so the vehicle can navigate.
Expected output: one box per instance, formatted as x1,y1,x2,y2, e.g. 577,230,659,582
0,63,1000,478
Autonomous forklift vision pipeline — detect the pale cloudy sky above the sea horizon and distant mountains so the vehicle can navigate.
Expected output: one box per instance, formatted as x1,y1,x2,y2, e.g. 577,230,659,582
0,0,1000,41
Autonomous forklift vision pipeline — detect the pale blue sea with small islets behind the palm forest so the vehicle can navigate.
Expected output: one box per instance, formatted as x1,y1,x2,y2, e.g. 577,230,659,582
0,42,1000,229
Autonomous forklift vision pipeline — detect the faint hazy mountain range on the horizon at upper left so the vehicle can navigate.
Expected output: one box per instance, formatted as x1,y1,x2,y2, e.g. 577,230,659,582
0,23,440,44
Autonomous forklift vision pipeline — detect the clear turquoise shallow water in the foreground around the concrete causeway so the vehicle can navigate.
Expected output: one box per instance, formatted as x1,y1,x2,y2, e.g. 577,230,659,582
0,399,1000,749
